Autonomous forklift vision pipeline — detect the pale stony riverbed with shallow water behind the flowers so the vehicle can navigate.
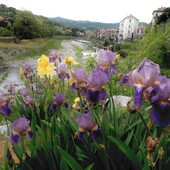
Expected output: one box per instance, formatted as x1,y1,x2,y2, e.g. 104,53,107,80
0,40,95,94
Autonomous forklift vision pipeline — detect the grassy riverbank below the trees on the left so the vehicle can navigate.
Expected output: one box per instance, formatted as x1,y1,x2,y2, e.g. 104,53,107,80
0,36,73,62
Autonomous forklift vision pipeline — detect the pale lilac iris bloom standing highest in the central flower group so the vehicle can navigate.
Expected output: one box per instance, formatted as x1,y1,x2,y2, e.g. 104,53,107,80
97,49,116,78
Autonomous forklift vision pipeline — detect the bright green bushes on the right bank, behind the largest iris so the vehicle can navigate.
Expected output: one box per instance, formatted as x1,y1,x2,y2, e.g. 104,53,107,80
116,22,170,76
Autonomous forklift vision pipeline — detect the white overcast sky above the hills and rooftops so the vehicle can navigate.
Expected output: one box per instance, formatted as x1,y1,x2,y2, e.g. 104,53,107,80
0,0,170,23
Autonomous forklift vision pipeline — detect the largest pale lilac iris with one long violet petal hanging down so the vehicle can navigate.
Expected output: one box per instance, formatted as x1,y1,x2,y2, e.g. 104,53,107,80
120,60,160,108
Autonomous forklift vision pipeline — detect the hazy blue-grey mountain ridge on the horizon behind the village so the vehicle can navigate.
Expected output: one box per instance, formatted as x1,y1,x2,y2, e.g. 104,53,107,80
49,17,147,30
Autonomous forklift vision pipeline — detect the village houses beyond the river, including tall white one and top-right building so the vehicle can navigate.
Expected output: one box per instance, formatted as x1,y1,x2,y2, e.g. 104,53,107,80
86,7,166,42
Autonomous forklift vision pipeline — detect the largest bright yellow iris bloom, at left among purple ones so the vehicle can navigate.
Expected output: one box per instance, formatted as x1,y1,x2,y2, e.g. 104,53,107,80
36,55,55,77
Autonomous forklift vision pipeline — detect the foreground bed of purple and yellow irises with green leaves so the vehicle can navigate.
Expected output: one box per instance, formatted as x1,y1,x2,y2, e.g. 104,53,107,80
0,50,170,170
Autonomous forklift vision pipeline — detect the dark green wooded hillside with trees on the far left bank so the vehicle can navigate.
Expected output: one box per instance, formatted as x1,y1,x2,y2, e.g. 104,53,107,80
0,4,72,39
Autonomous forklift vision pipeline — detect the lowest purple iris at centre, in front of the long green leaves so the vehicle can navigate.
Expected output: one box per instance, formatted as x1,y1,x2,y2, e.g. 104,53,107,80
76,112,102,141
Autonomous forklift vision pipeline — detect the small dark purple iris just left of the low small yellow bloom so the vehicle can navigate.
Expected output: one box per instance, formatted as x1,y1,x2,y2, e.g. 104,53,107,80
51,93,68,112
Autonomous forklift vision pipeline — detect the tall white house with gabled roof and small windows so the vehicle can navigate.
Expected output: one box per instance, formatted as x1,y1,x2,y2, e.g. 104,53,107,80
118,15,139,42
